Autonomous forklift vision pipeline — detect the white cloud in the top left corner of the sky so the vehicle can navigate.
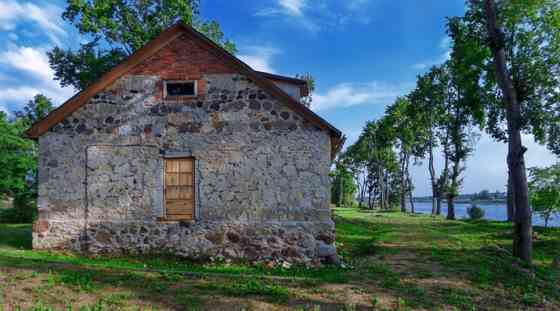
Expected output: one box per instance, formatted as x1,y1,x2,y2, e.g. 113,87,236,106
0,0,65,44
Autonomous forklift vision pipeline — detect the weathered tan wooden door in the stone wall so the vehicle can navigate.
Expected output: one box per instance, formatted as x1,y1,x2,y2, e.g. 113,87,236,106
165,158,195,220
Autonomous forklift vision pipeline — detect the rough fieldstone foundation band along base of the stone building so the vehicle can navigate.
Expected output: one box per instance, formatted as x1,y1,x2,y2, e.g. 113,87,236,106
33,222,338,264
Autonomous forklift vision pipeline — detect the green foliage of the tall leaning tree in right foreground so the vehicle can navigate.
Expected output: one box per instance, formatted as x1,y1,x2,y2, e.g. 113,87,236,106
461,0,560,152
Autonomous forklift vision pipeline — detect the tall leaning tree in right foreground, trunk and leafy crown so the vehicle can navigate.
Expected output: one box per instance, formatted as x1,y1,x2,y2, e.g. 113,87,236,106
462,0,560,263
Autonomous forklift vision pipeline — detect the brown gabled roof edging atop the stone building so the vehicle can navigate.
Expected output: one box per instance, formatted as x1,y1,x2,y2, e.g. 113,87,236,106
25,23,344,158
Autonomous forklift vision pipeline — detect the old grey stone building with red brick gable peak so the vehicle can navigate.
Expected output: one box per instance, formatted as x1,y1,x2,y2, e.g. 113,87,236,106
27,24,343,262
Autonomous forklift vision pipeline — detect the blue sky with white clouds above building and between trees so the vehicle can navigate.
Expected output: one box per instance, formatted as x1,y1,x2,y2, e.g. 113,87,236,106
0,0,556,195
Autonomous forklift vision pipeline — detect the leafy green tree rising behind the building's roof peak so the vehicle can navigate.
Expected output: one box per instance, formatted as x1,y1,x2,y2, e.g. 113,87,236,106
48,0,236,90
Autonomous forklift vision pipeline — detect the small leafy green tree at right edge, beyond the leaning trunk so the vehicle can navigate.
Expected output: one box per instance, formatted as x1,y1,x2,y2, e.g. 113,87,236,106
529,164,560,227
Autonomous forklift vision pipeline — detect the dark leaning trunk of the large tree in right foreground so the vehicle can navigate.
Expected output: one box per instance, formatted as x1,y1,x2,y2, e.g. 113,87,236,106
485,0,533,264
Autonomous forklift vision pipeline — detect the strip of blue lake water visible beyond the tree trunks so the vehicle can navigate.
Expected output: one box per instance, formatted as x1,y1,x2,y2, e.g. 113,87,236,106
408,202,560,227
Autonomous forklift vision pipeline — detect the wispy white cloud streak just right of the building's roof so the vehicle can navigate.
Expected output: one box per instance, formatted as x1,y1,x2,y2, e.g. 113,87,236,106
311,81,413,111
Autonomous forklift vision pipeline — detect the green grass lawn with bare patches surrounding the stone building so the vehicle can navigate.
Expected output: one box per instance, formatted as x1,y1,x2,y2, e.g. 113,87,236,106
0,209,560,311
